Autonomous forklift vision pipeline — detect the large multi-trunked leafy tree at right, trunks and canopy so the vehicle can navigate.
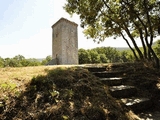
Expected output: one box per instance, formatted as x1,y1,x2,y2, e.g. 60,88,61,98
64,0,159,67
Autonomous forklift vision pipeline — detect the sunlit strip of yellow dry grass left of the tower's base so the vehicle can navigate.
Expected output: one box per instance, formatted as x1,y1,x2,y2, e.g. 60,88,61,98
0,65,81,84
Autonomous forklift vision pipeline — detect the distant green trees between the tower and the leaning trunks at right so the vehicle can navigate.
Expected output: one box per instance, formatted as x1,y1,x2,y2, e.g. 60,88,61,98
78,47,134,64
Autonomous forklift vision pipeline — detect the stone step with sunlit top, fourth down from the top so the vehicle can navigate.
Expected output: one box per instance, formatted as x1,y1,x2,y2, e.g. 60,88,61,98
109,85,137,98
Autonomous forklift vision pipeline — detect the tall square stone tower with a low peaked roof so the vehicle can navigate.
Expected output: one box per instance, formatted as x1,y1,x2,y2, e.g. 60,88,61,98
52,18,78,65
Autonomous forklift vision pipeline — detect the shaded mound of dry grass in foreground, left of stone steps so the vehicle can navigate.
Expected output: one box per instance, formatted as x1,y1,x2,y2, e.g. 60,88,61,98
0,68,127,120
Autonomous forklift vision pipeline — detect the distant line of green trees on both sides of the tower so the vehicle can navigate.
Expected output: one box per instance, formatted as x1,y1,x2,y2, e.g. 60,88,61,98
0,40,160,68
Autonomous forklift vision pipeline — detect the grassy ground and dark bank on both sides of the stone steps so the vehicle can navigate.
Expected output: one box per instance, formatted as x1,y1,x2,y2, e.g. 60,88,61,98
0,63,160,120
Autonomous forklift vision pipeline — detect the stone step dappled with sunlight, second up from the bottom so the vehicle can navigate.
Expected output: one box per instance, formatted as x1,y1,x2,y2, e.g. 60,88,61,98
121,97,152,113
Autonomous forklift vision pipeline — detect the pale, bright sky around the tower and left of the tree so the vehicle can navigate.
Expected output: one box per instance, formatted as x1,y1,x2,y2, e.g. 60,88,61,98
0,0,149,58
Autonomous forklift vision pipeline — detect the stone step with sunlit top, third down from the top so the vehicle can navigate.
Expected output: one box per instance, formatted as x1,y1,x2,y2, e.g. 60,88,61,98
100,77,123,86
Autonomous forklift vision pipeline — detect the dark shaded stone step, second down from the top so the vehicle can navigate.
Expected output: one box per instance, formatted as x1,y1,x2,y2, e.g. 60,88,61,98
93,71,123,78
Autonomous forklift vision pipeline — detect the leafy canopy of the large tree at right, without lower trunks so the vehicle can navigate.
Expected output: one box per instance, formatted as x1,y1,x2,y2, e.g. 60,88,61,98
64,0,159,41
